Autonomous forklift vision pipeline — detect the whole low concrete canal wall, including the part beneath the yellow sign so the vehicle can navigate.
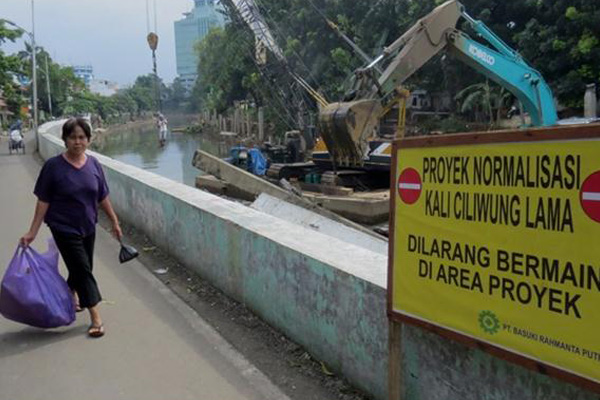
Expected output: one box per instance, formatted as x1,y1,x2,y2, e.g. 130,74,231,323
40,125,598,400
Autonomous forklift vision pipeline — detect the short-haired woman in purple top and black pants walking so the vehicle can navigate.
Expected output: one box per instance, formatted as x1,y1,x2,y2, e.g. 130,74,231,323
21,118,123,337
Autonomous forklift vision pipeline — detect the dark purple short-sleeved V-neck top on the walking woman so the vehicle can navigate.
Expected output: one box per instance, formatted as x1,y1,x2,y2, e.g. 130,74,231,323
33,154,108,236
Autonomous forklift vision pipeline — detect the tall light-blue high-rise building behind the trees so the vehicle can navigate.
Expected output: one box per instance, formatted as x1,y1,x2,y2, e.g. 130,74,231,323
174,0,225,91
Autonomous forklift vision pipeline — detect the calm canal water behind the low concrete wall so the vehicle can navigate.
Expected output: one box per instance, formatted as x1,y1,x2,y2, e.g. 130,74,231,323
92,118,227,186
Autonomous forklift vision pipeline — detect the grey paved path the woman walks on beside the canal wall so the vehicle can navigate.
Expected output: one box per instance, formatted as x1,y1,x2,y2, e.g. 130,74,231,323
0,135,286,400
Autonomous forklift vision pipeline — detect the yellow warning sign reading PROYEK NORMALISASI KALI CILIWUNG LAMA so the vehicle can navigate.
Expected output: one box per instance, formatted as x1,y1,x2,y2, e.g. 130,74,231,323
390,139,600,383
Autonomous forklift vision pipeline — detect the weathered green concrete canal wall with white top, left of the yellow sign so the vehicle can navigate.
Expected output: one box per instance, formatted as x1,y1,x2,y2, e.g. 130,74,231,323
40,122,387,398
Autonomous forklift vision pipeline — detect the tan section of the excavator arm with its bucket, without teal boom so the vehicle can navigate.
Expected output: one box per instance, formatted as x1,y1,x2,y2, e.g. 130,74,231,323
319,1,461,166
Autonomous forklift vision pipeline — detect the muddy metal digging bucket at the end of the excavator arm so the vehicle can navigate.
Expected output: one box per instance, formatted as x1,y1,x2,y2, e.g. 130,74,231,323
319,100,382,166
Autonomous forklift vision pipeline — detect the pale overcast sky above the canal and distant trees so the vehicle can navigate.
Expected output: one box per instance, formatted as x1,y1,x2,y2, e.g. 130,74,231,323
0,0,200,86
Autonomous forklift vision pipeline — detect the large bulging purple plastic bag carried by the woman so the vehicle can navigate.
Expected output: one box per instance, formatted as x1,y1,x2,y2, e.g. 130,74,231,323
0,239,75,328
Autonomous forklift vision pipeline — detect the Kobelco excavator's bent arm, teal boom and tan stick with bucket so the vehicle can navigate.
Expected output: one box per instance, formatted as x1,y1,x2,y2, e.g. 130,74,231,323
312,0,557,175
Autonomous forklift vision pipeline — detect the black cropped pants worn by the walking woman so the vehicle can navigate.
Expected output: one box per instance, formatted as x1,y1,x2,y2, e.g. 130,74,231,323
51,229,102,308
